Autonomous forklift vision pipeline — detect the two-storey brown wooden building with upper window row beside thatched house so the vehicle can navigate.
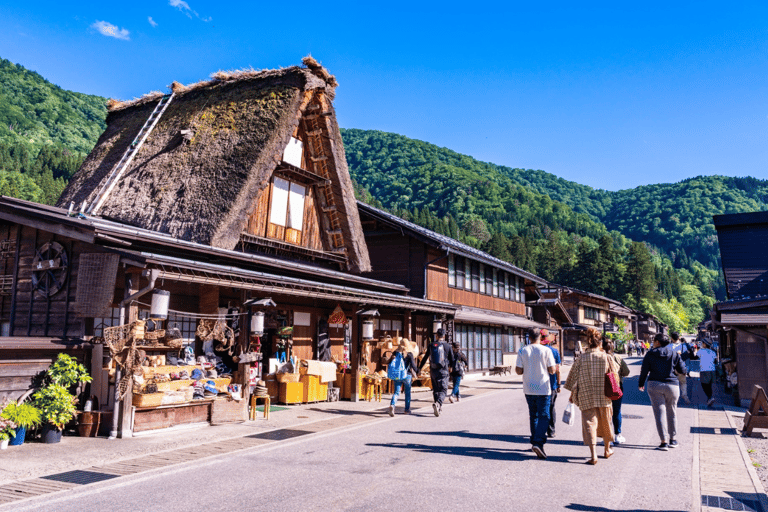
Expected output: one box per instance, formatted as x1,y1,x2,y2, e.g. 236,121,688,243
358,202,549,371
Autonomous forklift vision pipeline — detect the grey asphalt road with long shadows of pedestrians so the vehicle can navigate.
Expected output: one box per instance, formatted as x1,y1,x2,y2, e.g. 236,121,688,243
10,358,694,512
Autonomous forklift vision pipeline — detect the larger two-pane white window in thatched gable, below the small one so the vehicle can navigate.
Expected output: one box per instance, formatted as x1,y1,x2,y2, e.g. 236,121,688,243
267,176,307,244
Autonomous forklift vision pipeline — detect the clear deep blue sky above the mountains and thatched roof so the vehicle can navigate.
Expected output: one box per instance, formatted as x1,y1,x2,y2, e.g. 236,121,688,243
0,0,768,190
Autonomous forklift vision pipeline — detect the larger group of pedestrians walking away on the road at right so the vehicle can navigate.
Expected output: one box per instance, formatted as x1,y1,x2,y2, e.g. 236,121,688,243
516,329,717,465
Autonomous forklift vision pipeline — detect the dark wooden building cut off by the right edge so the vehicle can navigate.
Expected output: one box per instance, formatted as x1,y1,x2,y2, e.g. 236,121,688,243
710,212,768,403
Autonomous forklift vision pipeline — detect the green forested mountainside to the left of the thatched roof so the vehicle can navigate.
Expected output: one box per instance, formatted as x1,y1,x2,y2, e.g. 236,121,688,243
0,59,107,204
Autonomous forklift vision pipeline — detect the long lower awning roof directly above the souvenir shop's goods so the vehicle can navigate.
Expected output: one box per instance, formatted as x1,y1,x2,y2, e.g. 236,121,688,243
142,253,456,315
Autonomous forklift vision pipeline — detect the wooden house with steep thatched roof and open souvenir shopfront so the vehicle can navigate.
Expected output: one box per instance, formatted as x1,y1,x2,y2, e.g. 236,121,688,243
0,59,455,436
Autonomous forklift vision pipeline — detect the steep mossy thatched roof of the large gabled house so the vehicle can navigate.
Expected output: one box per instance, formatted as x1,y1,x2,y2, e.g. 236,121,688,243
58,58,370,272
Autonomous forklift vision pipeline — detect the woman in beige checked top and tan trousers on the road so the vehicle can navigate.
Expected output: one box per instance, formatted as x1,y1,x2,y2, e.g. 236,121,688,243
565,328,616,464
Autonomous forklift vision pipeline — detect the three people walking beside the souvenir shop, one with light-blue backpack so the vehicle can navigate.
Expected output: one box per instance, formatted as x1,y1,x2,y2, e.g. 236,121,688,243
387,329,469,416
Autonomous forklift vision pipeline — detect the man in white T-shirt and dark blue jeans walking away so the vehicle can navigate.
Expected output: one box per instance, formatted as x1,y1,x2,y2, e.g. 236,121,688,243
515,328,557,459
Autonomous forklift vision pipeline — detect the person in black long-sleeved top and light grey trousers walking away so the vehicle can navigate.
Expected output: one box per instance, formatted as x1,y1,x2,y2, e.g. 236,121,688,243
638,333,686,451
